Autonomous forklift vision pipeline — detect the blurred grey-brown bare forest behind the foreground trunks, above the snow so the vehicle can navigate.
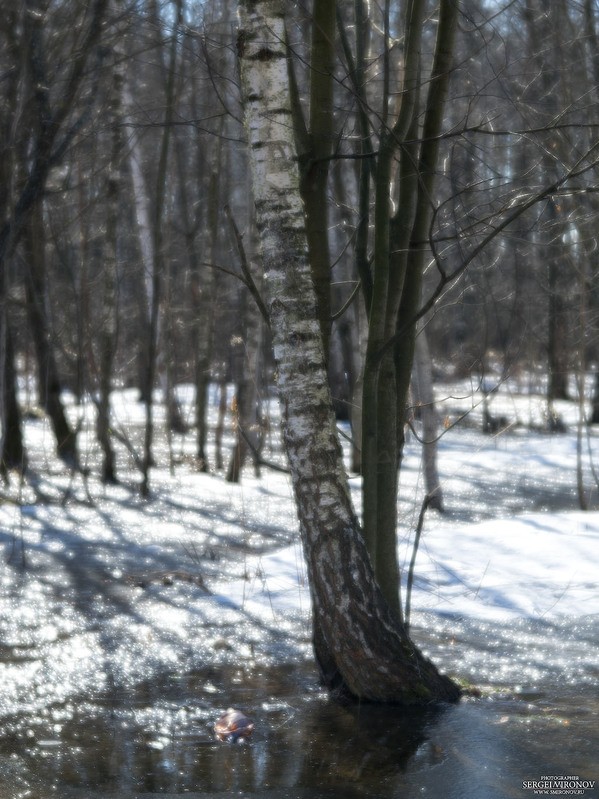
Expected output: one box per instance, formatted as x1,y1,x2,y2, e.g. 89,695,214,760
0,0,599,477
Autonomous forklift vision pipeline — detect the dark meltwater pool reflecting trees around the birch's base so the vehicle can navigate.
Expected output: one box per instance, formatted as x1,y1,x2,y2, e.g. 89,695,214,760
0,621,599,799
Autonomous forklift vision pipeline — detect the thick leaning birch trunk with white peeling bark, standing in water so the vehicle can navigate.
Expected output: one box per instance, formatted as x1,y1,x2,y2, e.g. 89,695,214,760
238,0,459,703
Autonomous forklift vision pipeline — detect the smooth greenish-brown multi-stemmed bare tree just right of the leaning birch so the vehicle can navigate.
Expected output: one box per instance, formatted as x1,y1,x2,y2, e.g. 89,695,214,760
362,0,458,616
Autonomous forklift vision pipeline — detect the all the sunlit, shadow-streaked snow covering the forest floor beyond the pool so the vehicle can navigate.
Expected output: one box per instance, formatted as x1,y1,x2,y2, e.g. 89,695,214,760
0,378,599,716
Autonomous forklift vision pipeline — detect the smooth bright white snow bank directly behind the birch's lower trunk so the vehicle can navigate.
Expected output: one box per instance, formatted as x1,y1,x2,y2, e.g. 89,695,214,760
227,512,599,623
